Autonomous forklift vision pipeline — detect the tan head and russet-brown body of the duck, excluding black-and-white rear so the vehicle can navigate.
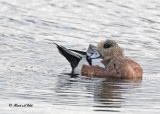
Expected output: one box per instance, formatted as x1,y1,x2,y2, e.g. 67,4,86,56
81,39,143,79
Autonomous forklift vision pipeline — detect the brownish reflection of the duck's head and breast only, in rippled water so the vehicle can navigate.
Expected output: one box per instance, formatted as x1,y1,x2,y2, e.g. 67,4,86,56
93,78,142,112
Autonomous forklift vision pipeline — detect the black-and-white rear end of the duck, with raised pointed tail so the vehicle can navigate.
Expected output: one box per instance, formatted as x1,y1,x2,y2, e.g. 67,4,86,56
53,42,105,75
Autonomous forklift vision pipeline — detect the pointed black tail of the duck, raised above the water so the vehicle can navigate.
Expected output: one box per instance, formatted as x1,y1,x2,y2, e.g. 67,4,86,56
53,42,82,73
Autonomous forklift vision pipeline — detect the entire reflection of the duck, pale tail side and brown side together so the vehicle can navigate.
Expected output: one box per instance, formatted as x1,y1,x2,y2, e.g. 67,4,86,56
53,75,142,112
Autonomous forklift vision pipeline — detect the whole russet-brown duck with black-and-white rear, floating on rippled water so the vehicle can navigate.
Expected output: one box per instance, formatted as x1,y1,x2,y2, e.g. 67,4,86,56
54,40,143,79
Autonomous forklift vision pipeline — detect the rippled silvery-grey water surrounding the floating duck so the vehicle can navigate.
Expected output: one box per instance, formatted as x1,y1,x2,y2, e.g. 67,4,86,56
0,0,160,114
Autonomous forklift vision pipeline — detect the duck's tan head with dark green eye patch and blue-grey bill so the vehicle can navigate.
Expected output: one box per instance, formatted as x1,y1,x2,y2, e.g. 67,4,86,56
91,40,124,59
